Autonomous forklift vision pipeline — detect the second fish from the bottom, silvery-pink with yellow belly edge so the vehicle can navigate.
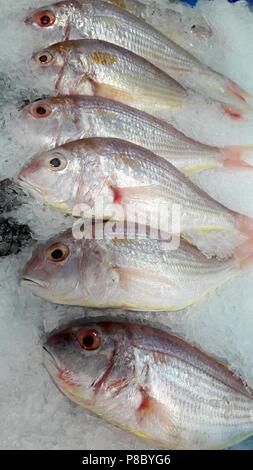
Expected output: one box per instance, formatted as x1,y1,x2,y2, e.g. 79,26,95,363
21,226,253,312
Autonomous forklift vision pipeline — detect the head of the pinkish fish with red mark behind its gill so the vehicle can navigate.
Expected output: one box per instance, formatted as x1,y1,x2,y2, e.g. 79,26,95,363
19,147,81,208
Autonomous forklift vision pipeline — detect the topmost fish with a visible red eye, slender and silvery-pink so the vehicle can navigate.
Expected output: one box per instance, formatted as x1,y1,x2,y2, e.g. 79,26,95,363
26,0,247,105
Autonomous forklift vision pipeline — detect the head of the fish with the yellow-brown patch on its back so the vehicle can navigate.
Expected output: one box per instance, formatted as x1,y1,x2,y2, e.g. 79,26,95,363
32,41,92,95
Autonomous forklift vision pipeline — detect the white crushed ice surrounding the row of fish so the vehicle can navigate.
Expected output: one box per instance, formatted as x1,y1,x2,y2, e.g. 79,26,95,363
0,0,253,449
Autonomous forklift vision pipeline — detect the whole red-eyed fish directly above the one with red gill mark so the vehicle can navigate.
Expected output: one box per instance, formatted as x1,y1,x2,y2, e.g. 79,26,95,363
19,96,252,174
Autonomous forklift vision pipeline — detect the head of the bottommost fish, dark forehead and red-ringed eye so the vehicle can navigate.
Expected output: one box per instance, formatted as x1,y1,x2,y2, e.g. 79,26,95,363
44,320,134,411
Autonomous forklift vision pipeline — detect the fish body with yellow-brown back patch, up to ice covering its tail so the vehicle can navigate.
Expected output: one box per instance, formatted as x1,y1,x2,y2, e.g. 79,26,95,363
33,39,187,114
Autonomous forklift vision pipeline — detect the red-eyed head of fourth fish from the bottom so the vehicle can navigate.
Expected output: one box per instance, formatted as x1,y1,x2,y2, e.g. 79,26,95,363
17,97,87,150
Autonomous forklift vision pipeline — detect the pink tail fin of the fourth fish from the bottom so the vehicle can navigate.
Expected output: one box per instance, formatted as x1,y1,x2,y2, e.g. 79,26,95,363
221,145,253,169
